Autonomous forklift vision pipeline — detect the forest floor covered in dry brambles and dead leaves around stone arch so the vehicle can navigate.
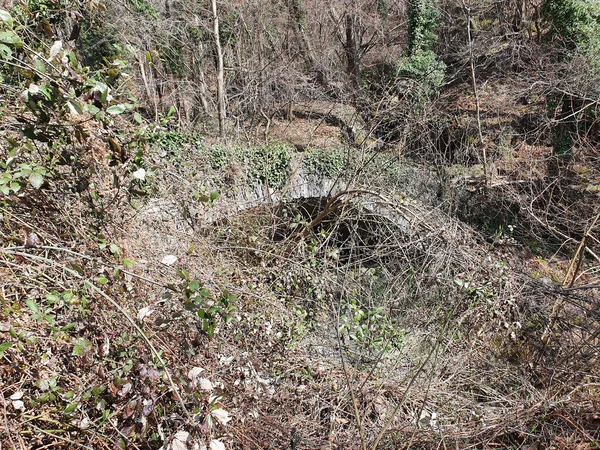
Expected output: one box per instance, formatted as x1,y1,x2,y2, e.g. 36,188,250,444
0,98,600,450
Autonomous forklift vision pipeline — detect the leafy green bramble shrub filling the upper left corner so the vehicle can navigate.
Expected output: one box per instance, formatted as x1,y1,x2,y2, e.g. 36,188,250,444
0,2,136,195
